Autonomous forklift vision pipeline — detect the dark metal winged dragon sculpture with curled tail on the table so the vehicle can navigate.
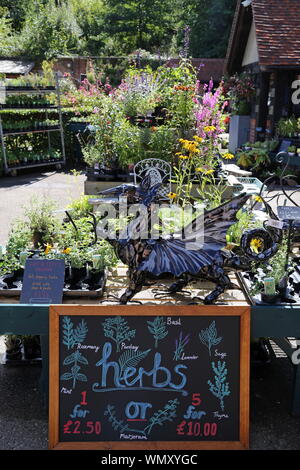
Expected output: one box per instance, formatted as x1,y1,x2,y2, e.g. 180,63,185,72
98,178,282,304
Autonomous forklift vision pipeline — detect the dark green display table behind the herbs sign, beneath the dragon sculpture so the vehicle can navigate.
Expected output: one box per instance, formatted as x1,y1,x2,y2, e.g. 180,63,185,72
0,267,300,416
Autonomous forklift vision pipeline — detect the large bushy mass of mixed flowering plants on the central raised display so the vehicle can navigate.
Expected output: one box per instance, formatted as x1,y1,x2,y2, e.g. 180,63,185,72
65,58,230,169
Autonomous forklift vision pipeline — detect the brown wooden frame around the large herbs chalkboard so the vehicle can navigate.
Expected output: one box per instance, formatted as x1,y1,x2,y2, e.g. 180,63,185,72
49,305,251,450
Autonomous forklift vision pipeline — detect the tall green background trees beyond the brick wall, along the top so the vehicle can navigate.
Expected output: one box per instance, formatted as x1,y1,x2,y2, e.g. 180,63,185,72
0,0,235,58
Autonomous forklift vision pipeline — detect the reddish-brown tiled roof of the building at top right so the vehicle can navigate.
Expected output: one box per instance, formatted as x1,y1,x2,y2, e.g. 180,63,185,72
252,0,300,66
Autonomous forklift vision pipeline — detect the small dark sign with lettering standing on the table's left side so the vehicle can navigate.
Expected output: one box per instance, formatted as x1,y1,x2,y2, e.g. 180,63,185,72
20,258,65,304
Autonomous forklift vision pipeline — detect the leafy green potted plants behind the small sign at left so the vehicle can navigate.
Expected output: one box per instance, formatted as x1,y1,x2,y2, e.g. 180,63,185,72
0,196,118,274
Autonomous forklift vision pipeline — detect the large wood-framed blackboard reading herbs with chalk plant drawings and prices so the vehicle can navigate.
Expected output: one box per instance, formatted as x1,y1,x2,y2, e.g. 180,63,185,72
49,305,250,450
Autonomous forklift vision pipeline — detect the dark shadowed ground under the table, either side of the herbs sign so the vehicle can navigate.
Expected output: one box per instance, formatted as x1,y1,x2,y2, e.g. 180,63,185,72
0,346,300,451
